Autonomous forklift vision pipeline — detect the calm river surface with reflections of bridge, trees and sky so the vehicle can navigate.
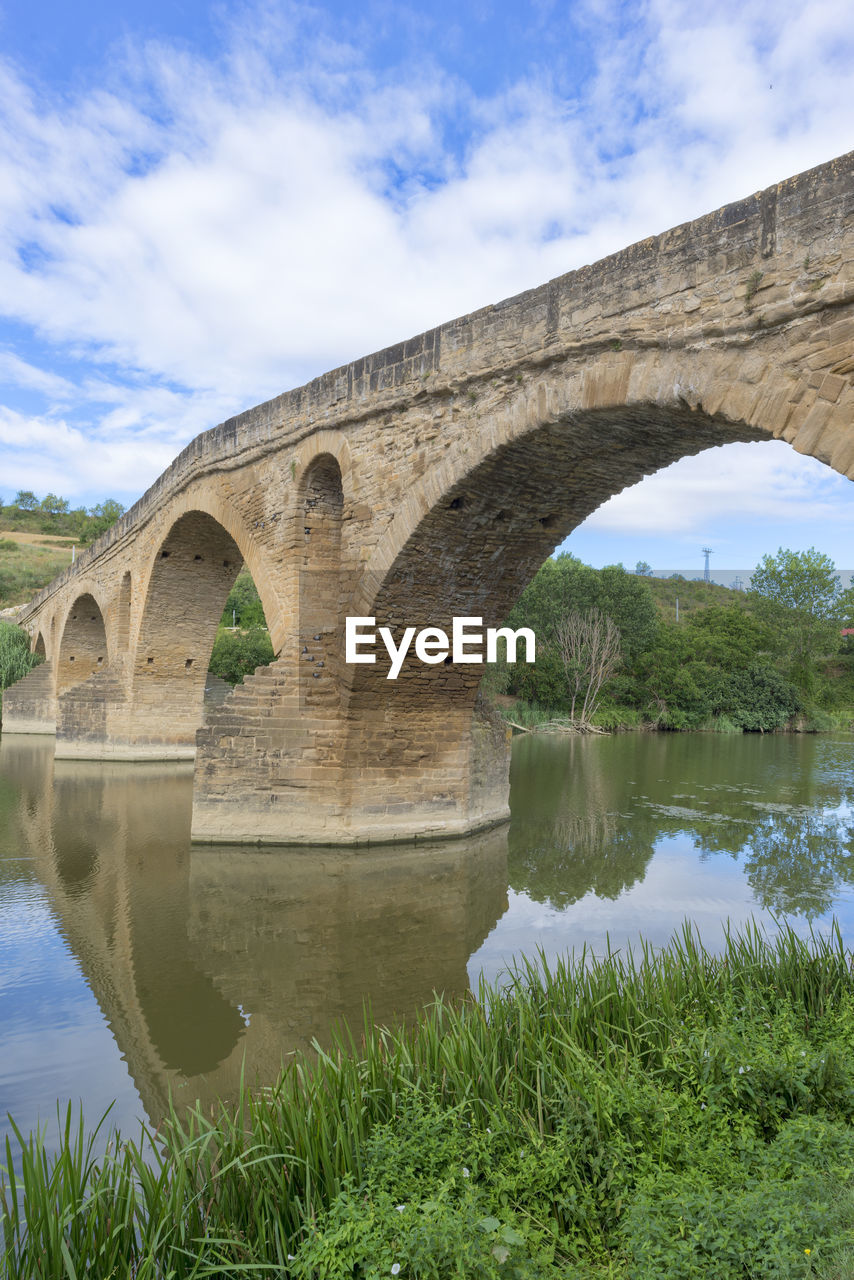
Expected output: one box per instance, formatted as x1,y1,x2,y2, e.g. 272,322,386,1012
0,735,854,1152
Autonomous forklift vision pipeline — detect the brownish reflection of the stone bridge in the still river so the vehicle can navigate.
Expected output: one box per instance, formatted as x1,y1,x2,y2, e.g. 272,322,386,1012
0,737,507,1124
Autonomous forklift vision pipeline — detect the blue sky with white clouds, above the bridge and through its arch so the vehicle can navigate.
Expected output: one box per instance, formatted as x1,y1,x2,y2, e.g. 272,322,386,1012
0,0,854,576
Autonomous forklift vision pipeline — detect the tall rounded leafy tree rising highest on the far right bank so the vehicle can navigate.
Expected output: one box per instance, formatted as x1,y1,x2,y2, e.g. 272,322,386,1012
750,547,841,691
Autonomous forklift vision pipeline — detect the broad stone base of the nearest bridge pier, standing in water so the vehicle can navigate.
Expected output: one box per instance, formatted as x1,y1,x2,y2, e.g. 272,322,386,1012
192,663,510,845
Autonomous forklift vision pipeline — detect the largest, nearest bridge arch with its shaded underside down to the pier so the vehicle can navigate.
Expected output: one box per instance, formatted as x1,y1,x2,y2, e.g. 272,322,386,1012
346,337,854,799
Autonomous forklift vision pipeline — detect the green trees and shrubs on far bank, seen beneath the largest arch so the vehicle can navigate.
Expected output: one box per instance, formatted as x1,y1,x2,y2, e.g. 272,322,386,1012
487,549,854,732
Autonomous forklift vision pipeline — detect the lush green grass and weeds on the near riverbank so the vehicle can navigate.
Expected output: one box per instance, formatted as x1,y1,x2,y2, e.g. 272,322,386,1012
0,928,854,1280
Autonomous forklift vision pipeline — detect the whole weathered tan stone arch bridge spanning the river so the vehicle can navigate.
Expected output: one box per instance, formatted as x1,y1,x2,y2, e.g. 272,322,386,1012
3,154,854,844
